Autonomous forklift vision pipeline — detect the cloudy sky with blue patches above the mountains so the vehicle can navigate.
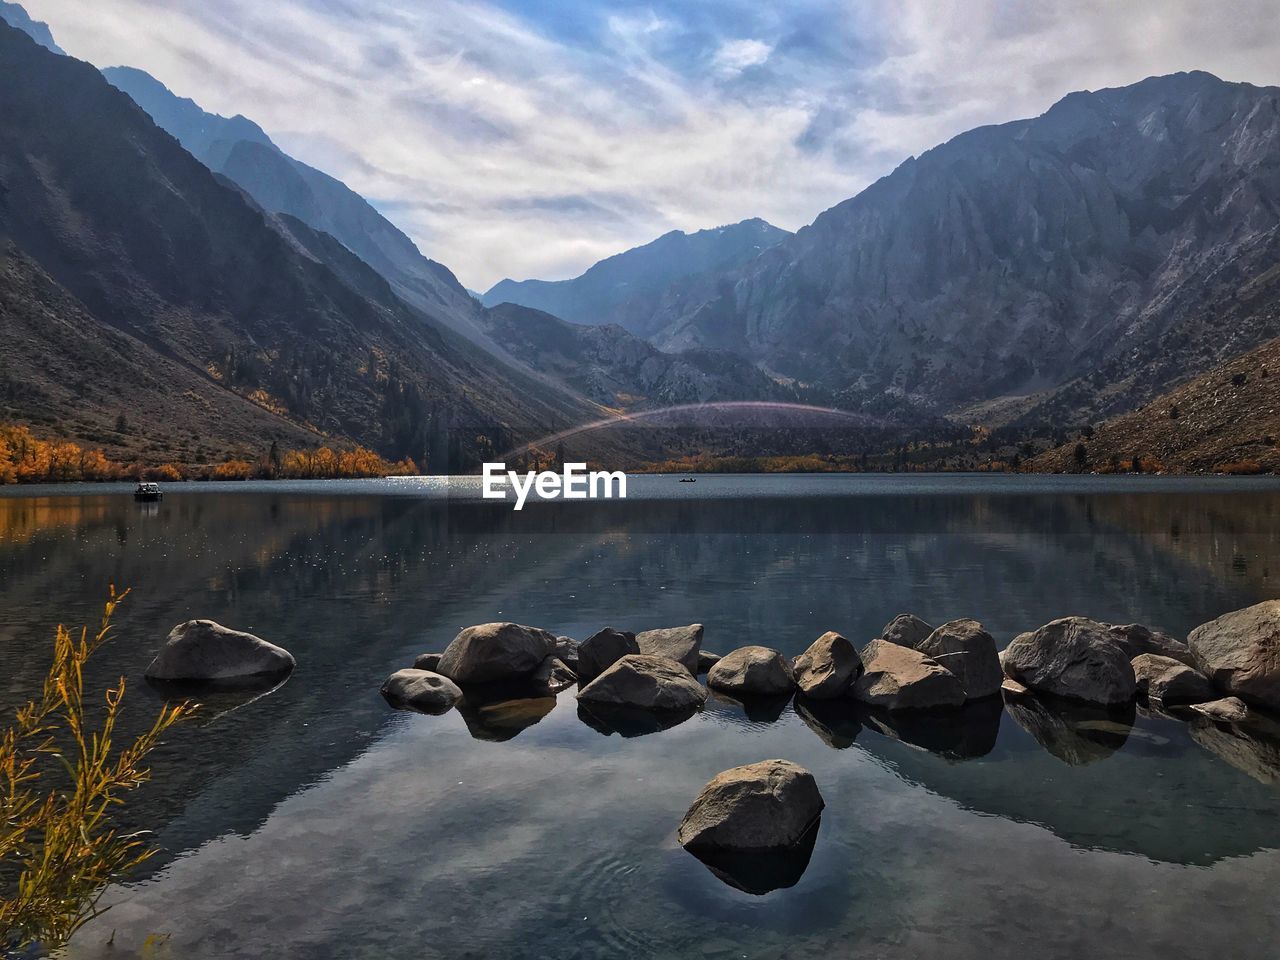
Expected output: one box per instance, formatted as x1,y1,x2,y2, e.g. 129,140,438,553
24,0,1280,289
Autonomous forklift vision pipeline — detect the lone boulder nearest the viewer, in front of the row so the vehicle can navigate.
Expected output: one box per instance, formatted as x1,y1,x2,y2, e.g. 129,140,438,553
677,760,823,852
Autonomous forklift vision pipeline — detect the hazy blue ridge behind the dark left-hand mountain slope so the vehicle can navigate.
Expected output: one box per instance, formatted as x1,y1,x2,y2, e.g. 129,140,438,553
102,67,479,333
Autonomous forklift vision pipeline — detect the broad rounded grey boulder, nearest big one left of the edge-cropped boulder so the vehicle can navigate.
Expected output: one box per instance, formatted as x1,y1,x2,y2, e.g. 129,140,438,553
1001,617,1137,704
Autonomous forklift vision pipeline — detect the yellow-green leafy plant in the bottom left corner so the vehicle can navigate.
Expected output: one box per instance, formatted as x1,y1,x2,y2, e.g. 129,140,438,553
0,586,195,948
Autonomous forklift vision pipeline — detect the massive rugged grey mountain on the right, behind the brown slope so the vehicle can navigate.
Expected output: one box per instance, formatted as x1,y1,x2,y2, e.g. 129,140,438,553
653,73,1280,422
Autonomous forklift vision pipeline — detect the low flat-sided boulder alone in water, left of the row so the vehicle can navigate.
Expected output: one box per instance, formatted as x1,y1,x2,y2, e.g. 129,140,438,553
146,620,297,681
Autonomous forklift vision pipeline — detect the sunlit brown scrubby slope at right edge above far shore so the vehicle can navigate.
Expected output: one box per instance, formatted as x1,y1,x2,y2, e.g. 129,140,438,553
1029,339,1280,472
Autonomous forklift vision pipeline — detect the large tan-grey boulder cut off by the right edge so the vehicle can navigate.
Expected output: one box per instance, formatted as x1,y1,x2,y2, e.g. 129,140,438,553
1187,600,1280,710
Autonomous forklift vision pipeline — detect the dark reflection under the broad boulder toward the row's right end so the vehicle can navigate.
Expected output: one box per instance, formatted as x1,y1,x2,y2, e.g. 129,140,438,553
1005,695,1134,767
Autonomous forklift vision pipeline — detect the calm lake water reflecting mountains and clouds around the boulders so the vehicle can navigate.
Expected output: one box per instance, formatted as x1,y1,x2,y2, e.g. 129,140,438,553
0,476,1280,960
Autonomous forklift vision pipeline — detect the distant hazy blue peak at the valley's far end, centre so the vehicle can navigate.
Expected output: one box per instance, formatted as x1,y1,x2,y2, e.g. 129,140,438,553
480,219,791,335
